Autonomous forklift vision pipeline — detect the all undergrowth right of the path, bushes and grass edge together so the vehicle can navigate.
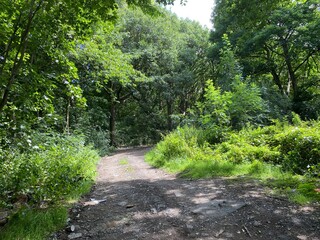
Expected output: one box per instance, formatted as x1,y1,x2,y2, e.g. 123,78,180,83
146,124,320,204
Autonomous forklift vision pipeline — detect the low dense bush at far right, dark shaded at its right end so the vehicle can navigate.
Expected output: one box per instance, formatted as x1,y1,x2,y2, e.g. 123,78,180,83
210,119,320,176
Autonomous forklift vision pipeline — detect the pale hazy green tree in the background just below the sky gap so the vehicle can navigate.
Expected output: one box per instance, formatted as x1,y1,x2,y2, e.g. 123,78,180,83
120,7,208,133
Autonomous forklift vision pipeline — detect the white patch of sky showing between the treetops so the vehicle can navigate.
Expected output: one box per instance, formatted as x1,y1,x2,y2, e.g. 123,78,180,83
168,0,214,29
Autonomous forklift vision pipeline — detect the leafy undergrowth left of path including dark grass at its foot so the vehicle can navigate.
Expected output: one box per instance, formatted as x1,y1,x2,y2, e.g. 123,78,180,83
0,134,99,240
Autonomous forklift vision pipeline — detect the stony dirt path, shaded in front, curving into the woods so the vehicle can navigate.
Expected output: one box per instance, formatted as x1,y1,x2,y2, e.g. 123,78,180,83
56,148,320,240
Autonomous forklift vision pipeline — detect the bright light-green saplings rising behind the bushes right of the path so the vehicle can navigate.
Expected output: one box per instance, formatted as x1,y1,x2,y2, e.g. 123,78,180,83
197,76,268,143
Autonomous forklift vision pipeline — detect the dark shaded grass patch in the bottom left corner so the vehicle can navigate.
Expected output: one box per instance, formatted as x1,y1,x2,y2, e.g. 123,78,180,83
0,206,68,240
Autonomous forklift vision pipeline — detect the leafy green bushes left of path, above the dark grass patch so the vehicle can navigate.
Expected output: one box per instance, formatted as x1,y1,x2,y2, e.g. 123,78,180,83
0,134,99,205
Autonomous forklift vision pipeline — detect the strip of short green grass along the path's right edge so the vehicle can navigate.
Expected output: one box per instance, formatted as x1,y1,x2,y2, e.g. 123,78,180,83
146,152,320,205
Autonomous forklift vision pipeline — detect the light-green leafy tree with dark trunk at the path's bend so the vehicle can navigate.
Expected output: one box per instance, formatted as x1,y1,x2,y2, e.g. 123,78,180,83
76,23,143,146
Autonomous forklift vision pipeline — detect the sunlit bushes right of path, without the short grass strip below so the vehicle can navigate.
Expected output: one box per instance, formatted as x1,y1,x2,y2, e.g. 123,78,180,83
150,119,320,176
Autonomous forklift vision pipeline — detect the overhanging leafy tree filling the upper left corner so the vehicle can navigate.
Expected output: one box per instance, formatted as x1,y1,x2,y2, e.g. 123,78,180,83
0,0,186,147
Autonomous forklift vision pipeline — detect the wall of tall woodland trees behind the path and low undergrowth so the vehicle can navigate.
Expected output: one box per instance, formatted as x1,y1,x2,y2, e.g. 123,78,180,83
0,1,320,148
